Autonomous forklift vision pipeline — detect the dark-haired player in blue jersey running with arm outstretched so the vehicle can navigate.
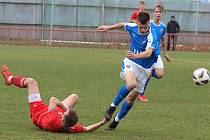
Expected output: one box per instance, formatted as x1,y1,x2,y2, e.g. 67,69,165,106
97,12,160,130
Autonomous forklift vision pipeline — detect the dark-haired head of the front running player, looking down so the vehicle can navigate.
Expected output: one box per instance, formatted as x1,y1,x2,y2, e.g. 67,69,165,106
136,12,150,34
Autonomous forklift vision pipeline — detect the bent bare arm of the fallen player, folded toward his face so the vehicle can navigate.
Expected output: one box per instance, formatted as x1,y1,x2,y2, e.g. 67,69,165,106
48,97,68,112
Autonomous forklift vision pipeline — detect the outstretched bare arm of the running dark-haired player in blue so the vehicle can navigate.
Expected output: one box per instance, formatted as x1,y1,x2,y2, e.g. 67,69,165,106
97,22,126,32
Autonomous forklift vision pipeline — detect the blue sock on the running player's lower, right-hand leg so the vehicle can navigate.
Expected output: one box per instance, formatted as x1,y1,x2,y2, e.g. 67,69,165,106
115,101,133,122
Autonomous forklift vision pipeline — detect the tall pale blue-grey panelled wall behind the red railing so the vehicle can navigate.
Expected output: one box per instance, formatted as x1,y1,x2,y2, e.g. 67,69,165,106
0,0,210,32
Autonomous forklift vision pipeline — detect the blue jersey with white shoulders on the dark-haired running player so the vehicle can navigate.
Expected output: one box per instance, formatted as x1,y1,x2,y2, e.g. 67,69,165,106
124,23,160,69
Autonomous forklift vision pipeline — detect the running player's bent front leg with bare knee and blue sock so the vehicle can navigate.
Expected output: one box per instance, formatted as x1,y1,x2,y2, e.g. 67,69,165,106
105,71,137,120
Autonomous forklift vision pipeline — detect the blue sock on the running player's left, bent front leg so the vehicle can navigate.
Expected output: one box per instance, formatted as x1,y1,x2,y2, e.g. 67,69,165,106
113,85,130,106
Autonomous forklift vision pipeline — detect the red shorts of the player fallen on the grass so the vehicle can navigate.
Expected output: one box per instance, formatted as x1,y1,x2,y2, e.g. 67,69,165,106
30,101,48,124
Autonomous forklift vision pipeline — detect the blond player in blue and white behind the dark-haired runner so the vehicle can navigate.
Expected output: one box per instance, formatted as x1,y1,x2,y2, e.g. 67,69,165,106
138,5,171,102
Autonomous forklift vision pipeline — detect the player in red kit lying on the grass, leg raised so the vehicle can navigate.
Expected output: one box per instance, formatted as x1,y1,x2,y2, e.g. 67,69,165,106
1,65,107,133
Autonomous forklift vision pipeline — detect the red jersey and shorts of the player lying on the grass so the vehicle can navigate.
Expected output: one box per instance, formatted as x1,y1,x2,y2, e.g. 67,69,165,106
30,101,84,133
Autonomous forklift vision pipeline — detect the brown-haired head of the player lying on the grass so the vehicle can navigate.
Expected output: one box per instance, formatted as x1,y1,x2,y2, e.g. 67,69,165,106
63,108,79,130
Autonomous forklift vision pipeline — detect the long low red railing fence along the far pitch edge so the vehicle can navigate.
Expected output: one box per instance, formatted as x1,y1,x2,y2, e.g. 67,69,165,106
0,27,210,51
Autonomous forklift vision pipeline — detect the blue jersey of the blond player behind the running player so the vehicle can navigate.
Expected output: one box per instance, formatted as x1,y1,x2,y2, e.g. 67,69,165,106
150,20,166,53
